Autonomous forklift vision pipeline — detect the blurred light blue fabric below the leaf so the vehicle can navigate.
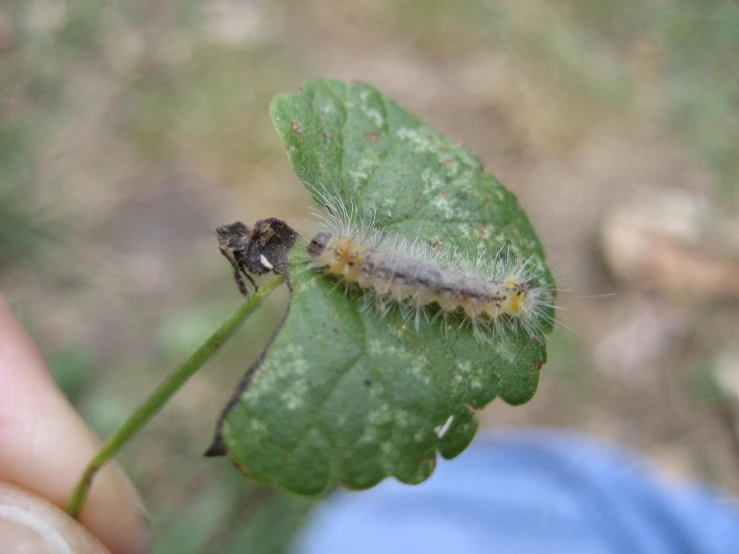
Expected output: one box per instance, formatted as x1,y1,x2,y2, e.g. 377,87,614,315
295,430,739,554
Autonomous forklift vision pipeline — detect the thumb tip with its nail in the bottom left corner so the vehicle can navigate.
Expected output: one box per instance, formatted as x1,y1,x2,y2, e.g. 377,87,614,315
0,482,108,554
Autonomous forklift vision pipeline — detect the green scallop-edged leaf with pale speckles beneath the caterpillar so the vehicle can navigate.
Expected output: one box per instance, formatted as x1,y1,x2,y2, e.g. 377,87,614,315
221,80,554,494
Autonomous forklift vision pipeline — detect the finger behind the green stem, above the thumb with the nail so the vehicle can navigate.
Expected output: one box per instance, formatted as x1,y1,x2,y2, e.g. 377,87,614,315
0,296,150,554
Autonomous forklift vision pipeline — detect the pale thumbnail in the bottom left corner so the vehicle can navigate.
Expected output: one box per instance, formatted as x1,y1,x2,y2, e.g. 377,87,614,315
0,504,74,554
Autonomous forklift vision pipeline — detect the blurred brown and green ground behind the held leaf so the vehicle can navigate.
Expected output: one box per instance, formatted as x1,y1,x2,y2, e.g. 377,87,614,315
0,0,739,553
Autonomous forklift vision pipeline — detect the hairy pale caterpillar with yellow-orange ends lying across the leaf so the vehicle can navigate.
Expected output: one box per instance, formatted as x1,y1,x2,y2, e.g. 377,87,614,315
307,195,556,338
